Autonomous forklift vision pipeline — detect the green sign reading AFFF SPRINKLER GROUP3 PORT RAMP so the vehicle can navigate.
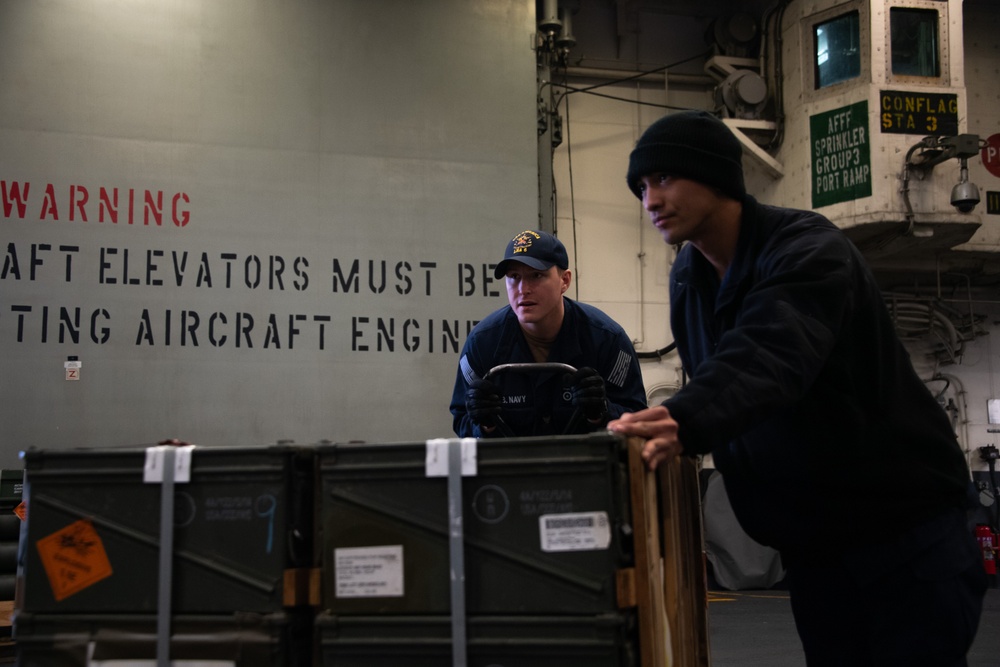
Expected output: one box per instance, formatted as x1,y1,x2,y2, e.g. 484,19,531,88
809,101,872,208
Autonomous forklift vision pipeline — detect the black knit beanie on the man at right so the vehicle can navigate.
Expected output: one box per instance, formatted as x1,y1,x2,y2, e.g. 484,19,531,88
626,111,746,200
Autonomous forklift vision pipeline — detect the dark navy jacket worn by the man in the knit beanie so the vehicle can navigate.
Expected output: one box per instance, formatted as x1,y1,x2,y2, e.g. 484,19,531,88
664,197,969,558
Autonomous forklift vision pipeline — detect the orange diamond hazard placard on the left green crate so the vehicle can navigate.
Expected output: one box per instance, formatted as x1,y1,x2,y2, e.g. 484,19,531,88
35,519,111,600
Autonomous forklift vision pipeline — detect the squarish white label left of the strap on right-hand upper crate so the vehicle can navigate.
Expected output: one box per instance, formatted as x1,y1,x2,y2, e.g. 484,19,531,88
333,544,403,598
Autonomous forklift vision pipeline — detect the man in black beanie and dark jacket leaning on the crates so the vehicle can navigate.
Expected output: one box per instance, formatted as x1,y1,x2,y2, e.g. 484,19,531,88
607,111,988,667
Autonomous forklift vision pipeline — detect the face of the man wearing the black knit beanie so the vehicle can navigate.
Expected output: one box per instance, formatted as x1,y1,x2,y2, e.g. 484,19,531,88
639,173,722,246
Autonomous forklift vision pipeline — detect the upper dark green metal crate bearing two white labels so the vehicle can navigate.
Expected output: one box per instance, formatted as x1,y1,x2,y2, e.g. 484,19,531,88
317,433,633,616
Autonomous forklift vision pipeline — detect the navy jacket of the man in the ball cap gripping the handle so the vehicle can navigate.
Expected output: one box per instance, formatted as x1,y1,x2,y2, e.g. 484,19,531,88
451,297,646,438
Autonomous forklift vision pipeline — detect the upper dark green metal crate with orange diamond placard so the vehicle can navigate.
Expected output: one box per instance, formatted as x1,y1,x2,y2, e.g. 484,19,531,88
19,445,314,614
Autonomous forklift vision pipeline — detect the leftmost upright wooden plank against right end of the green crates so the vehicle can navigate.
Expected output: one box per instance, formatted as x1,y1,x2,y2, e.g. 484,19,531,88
627,438,671,667
